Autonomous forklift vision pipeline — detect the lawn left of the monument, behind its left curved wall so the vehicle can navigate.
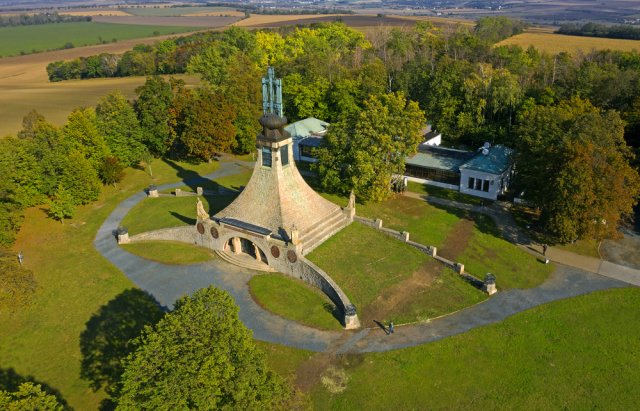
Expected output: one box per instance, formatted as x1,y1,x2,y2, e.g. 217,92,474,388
122,167,251,235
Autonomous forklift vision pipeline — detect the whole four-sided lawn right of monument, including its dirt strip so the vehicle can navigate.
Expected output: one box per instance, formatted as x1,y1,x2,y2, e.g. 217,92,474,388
304,222,486,326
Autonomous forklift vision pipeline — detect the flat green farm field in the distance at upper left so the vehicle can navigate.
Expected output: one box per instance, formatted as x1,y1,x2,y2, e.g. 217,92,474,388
0,22,198,57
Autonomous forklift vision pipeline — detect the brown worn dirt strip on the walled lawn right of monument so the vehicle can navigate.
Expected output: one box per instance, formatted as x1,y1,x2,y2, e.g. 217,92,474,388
360,259,442,327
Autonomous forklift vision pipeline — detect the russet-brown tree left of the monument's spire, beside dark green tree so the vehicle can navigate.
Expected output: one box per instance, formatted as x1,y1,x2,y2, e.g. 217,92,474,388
180,89,236,160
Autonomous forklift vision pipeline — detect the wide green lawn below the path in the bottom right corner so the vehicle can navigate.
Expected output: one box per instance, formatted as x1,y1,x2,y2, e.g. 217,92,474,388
308,288,640,410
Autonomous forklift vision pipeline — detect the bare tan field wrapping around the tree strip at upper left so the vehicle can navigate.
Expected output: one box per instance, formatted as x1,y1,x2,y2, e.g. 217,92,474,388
0,36,199,138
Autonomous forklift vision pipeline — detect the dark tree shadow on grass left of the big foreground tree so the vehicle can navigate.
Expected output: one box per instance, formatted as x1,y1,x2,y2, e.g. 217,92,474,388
80,288,164,400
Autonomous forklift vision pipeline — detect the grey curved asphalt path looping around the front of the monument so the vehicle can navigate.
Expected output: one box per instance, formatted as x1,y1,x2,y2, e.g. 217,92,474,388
94,162,628,353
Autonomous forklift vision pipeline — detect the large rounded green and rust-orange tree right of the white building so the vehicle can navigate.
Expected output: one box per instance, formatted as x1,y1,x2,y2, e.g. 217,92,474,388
517,98,640,242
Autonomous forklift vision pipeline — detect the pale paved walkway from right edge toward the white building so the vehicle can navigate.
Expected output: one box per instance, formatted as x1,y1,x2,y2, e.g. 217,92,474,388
404,191,640,286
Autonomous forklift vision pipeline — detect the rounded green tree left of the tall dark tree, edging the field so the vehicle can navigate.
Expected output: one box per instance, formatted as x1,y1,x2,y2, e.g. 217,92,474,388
96,91,145,166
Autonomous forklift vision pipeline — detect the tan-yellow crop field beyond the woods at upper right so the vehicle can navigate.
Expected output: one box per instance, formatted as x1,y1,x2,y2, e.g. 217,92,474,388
497,32,640,54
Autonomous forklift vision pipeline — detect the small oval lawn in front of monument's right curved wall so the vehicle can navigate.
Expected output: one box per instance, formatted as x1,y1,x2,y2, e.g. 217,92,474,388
249,274,343,330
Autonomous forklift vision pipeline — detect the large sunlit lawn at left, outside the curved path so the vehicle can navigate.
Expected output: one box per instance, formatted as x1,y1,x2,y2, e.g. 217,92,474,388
0,160,225,410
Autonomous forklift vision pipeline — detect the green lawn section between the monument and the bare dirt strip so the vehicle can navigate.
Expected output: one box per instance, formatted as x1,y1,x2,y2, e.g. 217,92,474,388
307,222,429,309
